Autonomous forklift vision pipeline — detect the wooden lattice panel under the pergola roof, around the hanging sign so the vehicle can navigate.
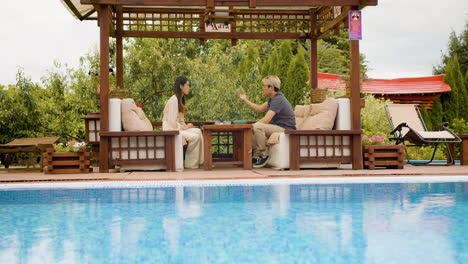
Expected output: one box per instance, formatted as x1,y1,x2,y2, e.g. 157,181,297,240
118,6,349,39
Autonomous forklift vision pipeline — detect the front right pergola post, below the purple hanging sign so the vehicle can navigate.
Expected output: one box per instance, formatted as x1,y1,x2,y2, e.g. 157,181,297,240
349,6,363,170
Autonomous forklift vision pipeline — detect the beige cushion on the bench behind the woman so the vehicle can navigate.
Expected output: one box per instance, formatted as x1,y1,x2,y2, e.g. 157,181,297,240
122,98,153,131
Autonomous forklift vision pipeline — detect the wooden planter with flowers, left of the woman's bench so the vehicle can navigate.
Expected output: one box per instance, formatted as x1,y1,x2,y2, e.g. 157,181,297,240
43,140,91,173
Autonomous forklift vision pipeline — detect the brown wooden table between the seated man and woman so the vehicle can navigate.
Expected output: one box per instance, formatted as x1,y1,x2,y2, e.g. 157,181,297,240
203,124,253,170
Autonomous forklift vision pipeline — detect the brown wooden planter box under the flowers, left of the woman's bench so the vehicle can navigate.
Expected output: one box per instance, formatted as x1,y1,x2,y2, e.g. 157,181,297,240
42,148,91,174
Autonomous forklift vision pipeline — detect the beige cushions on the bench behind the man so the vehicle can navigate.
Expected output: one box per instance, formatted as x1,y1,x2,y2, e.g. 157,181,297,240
295,98,338,130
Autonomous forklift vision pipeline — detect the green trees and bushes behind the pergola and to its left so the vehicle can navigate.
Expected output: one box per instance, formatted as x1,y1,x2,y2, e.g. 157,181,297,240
0,35,366,143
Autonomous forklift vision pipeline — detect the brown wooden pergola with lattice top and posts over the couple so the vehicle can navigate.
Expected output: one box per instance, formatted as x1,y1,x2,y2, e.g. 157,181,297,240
69,0,378,172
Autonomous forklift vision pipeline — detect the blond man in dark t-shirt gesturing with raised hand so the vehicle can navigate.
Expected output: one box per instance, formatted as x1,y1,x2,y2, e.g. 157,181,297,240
237,75,296,168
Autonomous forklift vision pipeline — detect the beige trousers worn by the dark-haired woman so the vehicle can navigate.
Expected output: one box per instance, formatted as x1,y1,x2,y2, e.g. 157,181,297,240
180,128,204,169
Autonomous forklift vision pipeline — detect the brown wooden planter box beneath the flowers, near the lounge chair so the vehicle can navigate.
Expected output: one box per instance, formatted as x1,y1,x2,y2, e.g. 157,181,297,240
362,145,406,170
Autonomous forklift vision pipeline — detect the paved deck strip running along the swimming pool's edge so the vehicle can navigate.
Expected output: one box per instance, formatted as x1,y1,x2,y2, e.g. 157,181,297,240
0,164,468,184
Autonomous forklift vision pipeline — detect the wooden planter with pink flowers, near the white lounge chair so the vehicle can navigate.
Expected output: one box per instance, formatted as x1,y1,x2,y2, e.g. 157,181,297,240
361,134,406,170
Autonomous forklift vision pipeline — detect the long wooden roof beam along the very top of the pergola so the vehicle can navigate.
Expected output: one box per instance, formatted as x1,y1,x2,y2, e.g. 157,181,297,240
80,0,378,7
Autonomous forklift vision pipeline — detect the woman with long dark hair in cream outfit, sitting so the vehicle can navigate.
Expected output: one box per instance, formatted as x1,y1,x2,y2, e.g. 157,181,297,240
163,76,203,169
